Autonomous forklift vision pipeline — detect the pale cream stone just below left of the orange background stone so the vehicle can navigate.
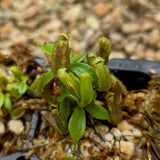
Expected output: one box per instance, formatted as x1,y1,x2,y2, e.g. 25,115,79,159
86,16,100,30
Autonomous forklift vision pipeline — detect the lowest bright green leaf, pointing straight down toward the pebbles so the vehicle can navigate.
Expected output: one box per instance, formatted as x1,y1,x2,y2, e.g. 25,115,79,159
69,107,86,143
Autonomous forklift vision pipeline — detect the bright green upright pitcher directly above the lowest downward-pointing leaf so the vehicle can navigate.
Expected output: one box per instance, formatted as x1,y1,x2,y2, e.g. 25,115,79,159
80,72,93,107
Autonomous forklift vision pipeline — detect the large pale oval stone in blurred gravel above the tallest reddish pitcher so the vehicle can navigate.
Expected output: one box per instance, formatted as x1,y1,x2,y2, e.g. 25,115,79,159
63,5,82,22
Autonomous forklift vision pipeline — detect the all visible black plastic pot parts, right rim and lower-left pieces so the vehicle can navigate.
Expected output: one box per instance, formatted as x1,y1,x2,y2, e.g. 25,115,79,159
0,58,160,160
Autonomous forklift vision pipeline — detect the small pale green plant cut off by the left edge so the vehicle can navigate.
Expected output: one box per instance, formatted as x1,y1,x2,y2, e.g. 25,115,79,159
0,66,28,119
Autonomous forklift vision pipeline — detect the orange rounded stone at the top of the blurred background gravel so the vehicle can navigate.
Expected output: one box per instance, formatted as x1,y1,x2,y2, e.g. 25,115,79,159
93,3,109,17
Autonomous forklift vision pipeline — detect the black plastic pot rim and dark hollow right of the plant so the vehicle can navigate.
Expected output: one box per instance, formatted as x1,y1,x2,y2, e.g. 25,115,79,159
108,59,160,90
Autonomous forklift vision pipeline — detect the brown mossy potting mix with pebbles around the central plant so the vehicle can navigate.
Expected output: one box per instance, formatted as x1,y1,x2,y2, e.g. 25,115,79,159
0,47,160,160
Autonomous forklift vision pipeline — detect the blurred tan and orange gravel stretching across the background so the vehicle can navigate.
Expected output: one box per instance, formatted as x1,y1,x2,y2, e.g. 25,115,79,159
0,0,160,62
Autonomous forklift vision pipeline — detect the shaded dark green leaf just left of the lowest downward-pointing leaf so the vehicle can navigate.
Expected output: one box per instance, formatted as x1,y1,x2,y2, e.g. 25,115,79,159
59,98,70,124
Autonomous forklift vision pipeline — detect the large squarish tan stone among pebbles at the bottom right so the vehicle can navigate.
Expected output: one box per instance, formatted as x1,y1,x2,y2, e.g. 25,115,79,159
120,140,134,160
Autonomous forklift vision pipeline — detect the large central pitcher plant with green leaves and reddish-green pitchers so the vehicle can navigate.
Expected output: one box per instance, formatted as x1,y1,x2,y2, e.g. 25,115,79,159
31,33,123,144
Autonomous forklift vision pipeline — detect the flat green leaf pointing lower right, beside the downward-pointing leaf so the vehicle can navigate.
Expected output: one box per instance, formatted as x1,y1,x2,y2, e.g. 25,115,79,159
85,104,110,120
